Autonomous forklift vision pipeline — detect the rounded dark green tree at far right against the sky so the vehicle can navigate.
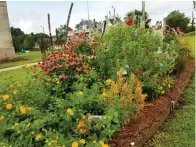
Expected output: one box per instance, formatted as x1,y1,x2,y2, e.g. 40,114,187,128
166,10,190,30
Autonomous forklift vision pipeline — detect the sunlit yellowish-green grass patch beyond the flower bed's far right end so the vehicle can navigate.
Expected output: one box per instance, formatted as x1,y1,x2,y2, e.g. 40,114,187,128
185,32,195,57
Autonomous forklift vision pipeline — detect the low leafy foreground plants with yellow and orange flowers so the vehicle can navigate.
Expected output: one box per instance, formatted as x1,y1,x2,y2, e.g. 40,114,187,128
0,70,145,147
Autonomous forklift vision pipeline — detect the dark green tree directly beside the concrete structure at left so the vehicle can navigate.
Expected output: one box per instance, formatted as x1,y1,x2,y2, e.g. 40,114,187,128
11,27,25,52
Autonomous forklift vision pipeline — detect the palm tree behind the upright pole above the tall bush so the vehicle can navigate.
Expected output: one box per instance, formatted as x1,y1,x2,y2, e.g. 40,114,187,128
124,10,151,28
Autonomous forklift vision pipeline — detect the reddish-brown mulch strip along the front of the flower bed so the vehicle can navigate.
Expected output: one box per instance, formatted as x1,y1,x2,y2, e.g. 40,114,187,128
110,59,195,147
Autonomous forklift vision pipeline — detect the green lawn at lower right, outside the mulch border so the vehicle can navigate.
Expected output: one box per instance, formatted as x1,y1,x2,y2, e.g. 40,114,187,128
145,78,195,147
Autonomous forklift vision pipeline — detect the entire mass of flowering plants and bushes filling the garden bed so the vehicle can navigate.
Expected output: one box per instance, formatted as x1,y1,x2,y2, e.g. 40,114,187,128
0,24,191,147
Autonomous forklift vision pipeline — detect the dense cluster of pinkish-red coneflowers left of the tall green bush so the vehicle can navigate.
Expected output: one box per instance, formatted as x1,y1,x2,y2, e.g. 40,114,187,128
38,49,89,79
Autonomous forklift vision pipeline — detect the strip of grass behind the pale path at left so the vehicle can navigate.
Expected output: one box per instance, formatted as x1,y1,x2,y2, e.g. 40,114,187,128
0,51,42,69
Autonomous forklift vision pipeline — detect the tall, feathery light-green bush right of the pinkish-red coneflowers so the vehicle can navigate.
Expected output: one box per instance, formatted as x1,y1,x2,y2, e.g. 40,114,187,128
92,24,177,99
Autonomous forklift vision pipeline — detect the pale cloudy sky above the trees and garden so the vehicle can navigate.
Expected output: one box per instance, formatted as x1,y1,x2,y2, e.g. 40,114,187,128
7,1,193,33
